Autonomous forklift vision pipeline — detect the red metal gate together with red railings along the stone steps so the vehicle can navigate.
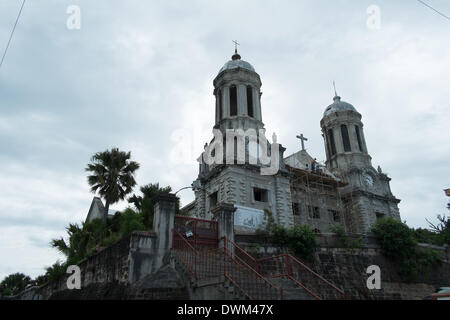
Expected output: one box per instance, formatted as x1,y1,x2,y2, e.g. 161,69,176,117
173,216,346,299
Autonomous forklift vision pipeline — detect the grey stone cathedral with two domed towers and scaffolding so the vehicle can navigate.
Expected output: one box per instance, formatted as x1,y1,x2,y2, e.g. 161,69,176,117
182,50,400,234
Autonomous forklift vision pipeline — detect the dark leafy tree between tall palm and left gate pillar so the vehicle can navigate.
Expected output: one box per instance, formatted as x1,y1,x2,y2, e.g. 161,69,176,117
128,183,179,228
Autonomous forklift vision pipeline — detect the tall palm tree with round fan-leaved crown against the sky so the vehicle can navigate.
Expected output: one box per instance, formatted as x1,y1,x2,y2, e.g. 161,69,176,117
85,148,139,222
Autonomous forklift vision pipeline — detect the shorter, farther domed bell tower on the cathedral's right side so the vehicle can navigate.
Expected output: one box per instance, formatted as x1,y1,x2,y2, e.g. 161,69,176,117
320,94,400,233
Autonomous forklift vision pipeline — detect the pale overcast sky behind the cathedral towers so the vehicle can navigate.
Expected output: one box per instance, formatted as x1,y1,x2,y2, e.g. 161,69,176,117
0,0,450,279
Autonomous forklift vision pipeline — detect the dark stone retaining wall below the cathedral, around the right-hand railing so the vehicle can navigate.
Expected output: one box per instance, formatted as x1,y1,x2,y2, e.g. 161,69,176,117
236,235,450,300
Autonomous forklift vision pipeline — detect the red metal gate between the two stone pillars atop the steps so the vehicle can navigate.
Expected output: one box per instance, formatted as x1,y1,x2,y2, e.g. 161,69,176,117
174,216,219,249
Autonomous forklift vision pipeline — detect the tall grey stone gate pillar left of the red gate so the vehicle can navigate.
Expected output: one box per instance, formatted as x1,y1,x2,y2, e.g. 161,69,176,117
153,193,178,270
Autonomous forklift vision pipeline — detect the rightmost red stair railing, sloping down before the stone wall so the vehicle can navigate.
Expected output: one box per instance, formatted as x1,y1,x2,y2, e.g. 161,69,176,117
257,254,346,300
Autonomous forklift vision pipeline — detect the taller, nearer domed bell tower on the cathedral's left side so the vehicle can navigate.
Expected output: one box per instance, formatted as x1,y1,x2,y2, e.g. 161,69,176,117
194,47,293,232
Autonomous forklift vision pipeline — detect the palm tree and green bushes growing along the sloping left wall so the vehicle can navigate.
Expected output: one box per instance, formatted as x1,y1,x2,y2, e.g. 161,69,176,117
0,148,183,296
